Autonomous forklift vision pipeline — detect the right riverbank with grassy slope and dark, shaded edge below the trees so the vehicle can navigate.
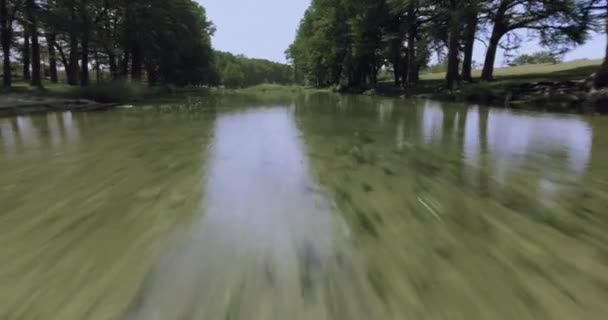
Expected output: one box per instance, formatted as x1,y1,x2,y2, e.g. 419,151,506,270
370,60,608,113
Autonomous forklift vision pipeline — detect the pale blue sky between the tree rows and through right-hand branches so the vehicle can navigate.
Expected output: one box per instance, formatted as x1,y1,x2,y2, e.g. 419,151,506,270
197,0,606,66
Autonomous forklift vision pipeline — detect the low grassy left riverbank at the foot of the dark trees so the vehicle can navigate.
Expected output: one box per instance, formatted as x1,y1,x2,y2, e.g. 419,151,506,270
0,82,330,116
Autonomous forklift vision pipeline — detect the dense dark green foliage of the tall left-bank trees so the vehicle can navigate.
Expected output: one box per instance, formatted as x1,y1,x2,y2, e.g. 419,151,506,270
2,0,219,86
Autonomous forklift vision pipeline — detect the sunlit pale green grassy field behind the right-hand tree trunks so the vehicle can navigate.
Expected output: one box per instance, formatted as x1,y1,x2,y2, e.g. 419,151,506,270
420,59,602,80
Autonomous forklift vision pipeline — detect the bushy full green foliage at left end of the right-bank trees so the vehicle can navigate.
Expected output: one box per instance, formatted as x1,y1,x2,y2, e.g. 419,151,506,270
286,0,388,86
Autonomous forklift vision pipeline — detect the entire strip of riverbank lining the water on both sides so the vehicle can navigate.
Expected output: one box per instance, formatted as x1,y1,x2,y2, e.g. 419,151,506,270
0,60,608,114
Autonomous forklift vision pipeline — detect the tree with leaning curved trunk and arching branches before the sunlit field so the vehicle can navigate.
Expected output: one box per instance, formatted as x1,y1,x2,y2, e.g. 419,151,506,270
482,0,588,81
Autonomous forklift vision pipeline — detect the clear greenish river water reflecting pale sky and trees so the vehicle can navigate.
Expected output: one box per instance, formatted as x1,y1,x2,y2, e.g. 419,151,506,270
0,94,608,320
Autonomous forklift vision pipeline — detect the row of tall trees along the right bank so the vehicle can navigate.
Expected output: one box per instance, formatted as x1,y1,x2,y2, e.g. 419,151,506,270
286,0,608,88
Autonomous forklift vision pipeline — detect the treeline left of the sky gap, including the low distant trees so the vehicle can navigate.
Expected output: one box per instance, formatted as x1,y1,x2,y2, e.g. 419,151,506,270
0,0,293,87
